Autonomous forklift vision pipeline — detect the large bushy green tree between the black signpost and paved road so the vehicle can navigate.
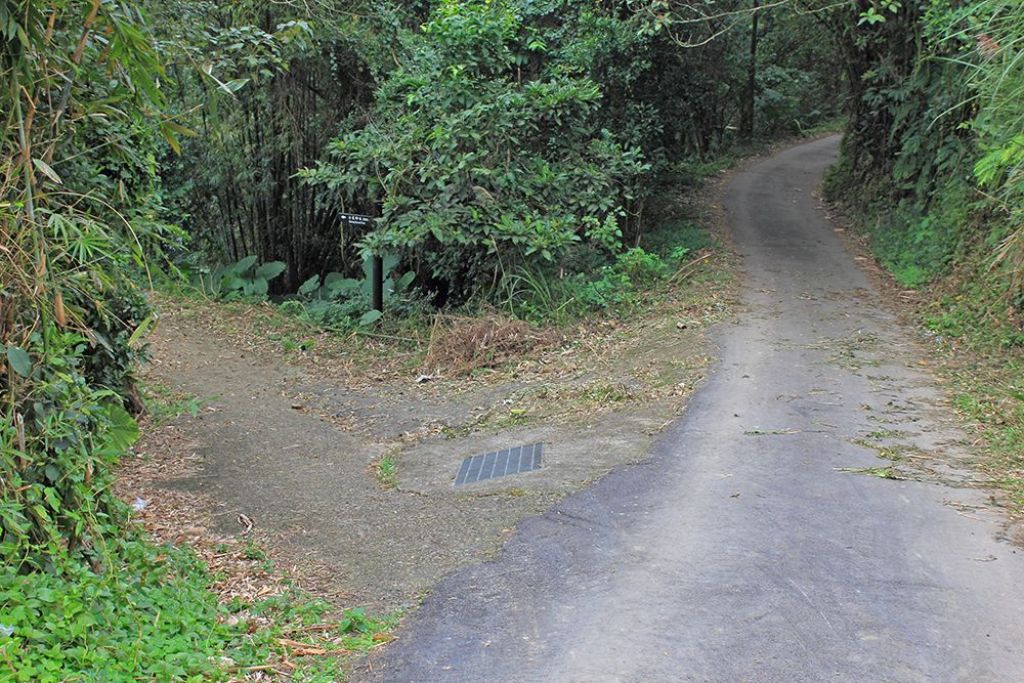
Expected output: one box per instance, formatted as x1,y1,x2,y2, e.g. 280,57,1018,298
306,2,648,299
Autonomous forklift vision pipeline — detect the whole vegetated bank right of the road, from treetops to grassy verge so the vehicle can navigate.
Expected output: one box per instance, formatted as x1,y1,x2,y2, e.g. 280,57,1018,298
826,0,1024,513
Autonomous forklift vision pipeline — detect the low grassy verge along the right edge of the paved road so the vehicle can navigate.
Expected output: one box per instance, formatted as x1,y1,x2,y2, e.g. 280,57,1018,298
827,194,1024,511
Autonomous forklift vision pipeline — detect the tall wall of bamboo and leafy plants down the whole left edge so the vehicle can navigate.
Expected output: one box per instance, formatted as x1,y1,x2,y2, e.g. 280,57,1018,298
0,0,234,681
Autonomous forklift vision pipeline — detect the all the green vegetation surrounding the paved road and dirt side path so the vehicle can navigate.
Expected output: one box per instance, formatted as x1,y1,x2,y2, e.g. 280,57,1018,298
0,0,1024,681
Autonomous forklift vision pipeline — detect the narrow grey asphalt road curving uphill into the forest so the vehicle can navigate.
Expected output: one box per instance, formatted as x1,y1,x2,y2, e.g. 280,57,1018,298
360,138,1024,682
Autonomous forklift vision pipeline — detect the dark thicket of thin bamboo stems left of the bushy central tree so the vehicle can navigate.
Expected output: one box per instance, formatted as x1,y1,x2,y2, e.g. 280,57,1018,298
147,1,383,291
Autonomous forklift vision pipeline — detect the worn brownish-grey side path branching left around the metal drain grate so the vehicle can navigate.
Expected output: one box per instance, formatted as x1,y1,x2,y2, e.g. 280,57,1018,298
125,244,722,610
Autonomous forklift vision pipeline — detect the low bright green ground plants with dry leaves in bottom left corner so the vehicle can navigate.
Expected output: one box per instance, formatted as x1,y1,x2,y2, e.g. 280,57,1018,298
0,537,395,683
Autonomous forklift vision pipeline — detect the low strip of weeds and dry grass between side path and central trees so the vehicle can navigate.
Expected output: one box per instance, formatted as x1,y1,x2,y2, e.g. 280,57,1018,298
158,151,737,385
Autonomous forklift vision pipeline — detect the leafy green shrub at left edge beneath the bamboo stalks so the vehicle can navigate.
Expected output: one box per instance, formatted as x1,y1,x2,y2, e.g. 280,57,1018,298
0,332,138,571
